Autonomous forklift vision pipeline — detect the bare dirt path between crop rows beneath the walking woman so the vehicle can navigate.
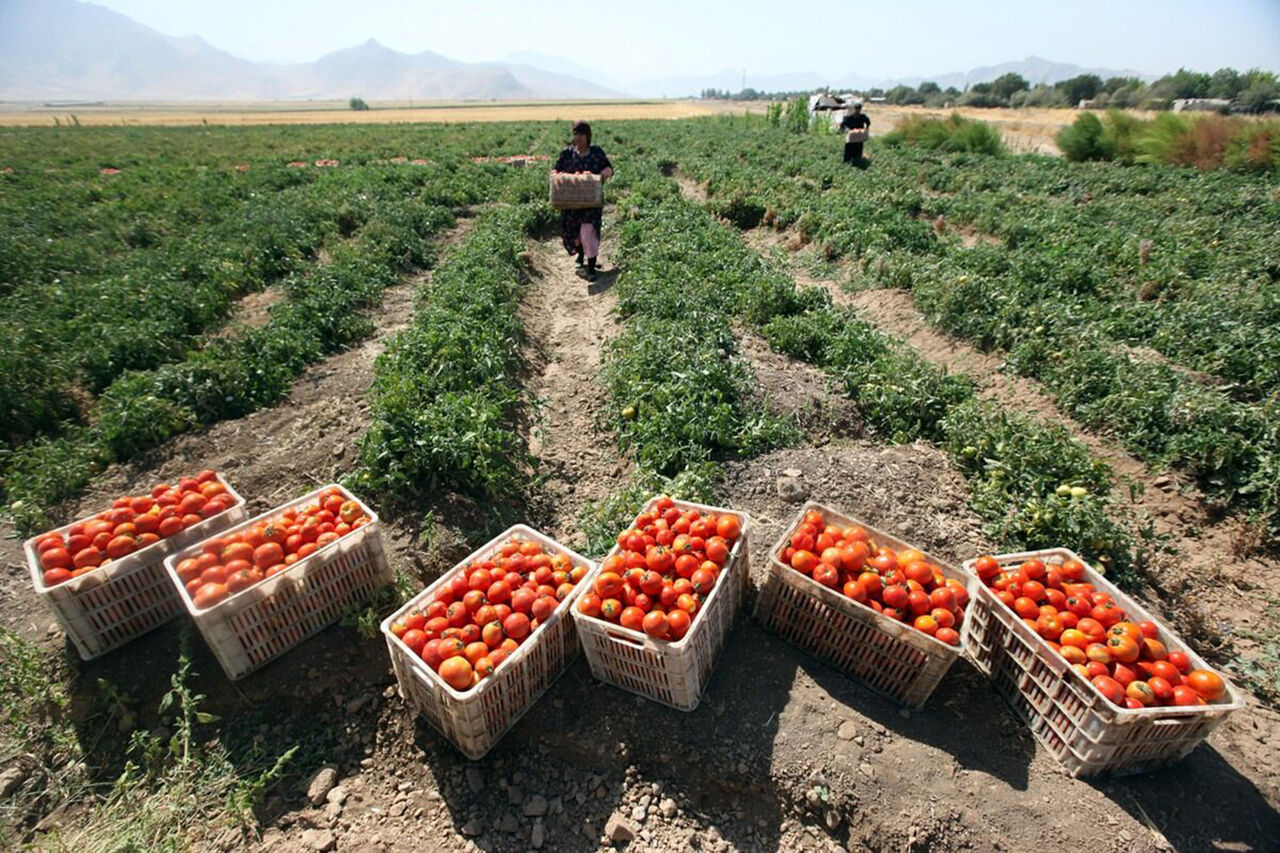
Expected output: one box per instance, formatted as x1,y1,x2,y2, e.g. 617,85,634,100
520,209,630,548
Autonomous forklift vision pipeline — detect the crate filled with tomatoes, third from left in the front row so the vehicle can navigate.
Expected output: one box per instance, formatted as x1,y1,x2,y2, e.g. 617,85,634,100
383,524,593,761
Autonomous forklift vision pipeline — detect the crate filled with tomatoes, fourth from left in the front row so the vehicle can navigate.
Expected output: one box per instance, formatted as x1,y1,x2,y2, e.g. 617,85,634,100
573,497,750,711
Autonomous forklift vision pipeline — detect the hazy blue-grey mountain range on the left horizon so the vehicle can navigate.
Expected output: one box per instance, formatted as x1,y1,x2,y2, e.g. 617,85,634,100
0,0,620,100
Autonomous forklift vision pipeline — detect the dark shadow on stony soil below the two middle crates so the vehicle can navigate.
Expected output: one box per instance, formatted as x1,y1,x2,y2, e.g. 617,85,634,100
416,615,795,850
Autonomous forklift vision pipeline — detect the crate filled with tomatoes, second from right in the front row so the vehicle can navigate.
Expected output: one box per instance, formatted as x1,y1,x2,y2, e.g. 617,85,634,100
755,501,969,708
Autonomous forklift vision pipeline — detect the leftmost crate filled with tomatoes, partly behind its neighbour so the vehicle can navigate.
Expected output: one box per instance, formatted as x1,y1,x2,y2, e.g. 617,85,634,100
23,470,244,661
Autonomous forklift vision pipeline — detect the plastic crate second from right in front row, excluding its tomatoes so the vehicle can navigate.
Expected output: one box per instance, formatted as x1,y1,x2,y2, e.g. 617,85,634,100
755,501,970,708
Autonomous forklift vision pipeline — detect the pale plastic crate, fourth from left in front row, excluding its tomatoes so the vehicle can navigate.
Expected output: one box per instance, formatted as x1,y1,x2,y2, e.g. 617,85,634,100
573,497,751,711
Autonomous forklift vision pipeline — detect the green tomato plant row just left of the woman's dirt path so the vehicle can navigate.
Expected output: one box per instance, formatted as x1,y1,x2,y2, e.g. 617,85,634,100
356,205,548,498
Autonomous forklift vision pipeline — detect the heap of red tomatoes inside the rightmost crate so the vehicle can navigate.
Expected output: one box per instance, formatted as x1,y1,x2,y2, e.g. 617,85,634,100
973,556,1226,710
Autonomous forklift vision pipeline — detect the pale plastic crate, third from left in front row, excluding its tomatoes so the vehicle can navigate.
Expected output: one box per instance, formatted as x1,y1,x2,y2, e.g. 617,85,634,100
383,524,595,761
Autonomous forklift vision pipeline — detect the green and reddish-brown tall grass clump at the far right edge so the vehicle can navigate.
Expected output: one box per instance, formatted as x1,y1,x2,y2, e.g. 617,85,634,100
1057,110,1280,172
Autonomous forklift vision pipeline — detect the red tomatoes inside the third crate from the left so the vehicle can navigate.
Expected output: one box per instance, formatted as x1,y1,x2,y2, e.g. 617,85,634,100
390,537,586,690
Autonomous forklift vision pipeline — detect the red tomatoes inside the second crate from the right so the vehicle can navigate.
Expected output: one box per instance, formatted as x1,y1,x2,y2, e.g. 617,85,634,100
778,510,969,646
